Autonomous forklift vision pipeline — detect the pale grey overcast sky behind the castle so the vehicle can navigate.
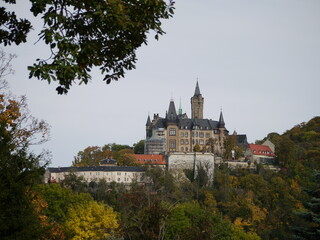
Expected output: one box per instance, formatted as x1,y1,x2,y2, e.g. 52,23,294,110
1,0,320,166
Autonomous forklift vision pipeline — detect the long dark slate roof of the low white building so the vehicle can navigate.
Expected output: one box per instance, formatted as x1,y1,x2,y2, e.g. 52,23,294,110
47,166,144,173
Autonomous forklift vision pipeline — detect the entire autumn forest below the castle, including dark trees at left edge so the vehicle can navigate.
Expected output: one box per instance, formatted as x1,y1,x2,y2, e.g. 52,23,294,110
0,86,320,240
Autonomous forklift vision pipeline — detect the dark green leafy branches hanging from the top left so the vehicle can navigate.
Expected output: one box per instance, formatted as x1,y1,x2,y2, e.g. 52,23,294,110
0,0,174,94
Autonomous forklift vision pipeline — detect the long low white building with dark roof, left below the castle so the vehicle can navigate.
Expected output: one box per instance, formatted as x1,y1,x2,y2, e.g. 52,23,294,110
44,166,144,184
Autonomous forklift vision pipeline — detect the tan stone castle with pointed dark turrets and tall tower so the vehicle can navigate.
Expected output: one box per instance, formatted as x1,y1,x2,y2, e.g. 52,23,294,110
145,82,228,156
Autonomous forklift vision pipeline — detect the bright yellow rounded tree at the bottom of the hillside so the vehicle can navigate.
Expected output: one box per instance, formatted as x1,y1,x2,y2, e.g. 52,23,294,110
65,201,119,240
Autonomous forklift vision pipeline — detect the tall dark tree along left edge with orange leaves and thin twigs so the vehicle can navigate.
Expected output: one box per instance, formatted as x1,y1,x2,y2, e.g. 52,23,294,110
0,52,49,239
